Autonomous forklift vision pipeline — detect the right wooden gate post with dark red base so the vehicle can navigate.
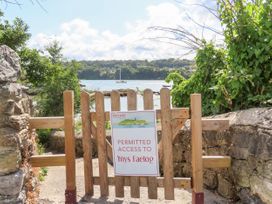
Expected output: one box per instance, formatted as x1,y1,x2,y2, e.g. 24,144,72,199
191,94,204,204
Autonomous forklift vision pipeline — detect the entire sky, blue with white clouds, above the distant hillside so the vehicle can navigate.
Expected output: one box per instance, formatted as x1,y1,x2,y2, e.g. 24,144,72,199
0,0,220,60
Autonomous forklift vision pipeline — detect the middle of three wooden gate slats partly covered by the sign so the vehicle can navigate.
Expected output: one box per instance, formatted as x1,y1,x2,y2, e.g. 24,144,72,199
127,90,140,198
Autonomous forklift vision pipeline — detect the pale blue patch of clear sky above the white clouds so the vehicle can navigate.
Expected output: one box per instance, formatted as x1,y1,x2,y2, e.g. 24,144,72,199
1,0,172,35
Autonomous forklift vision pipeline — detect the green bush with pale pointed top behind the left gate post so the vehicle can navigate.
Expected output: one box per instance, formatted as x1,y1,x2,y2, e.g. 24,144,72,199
37,42,80,116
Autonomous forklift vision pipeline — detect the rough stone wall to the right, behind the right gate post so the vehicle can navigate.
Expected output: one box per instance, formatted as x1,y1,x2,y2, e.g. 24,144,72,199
174,108,272,203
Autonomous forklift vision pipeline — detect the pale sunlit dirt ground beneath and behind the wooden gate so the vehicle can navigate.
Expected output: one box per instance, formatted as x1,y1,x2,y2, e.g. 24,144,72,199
39,158,228,204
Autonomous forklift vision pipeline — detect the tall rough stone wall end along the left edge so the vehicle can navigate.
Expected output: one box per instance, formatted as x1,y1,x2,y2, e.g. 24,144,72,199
0,46,37,204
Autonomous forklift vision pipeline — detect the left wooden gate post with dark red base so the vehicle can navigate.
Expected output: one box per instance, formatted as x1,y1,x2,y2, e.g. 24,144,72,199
63,91,76,204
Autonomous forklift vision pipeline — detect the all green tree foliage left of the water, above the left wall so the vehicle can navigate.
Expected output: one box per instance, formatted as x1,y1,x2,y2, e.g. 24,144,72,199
0,12,80,116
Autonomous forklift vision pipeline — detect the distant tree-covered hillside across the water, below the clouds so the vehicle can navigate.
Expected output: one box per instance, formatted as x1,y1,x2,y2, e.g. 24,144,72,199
78,58,194,80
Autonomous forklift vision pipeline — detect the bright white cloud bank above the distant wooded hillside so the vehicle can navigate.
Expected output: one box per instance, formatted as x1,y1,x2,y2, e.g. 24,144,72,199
30,0,220,60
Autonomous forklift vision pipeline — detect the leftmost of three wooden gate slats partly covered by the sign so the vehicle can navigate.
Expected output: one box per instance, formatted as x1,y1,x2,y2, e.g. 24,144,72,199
111,91,124,197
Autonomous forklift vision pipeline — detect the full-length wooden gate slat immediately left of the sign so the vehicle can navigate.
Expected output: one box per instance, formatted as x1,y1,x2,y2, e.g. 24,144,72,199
95,92,109,196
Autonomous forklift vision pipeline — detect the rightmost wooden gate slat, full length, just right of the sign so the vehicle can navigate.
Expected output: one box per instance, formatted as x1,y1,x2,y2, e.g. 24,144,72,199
160,88,174,200
